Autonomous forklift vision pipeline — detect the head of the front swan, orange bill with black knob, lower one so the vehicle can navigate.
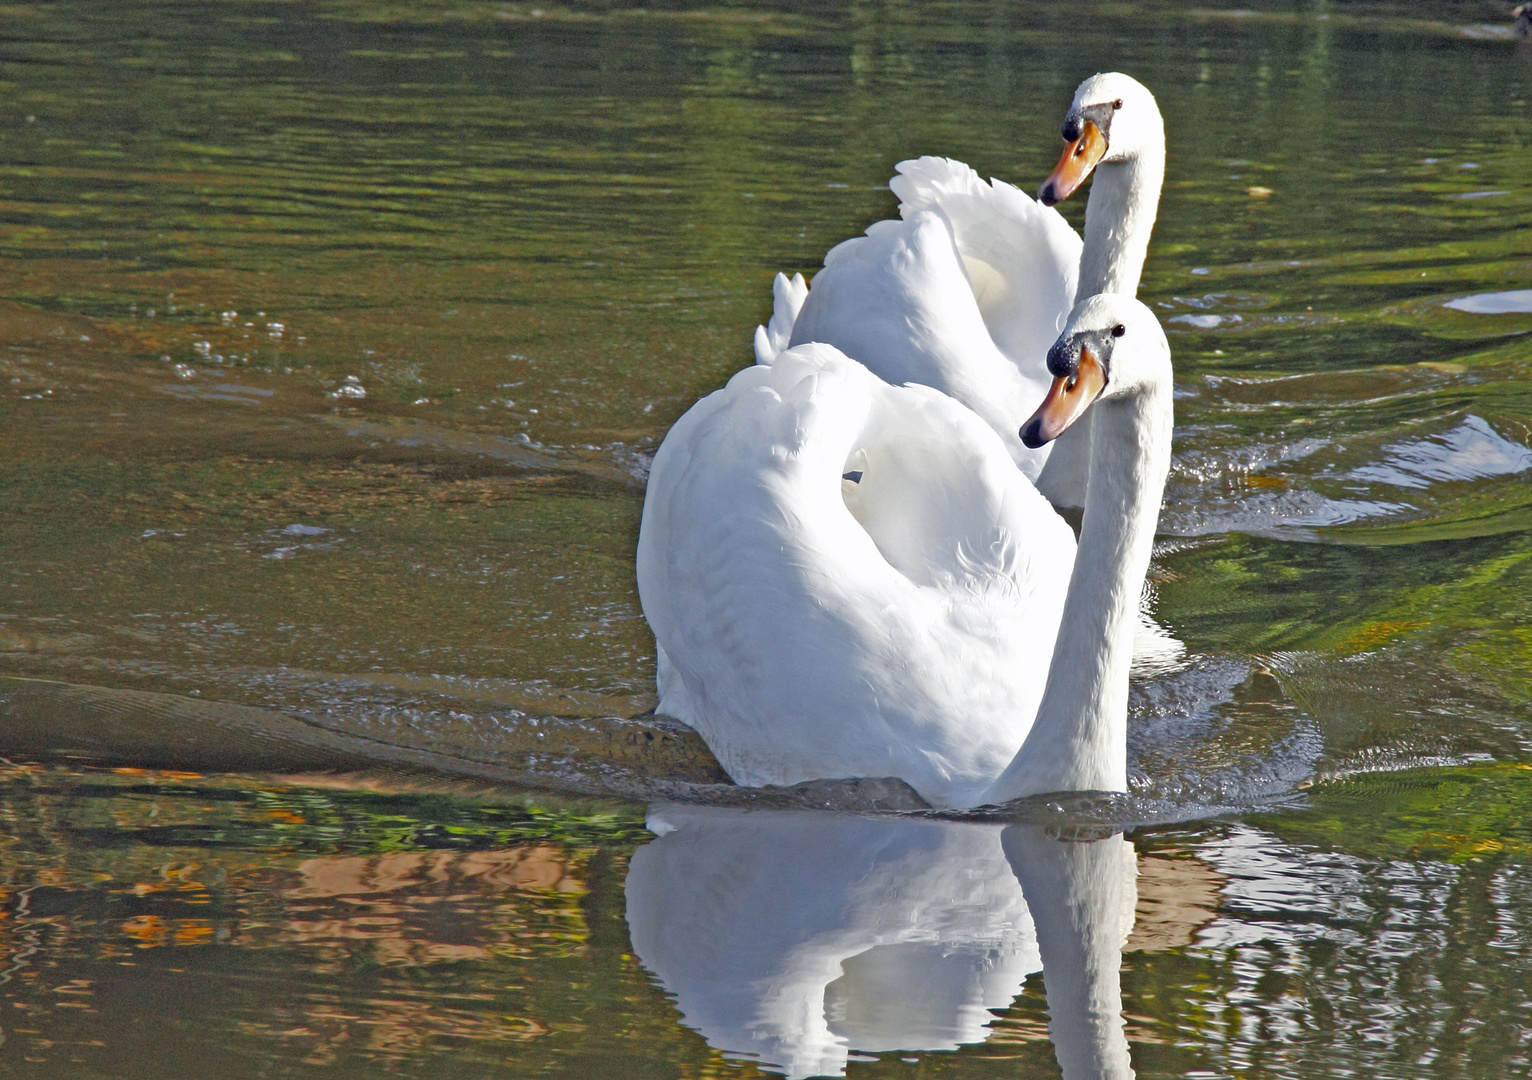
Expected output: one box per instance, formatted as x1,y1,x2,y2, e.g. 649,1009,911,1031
1020,293,1170,450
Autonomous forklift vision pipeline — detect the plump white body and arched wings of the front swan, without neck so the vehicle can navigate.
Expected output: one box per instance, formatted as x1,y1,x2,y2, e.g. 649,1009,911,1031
637,345,1074,804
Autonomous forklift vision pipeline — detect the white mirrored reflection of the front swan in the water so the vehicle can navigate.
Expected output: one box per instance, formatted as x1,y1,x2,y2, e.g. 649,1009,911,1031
627,806,1137,1080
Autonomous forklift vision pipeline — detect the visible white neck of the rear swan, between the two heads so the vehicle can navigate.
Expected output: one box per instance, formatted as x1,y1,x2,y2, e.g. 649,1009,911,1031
1074,133,1164,300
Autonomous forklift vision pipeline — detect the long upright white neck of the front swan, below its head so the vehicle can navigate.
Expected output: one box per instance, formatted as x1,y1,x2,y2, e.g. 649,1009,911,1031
985,385,1174,803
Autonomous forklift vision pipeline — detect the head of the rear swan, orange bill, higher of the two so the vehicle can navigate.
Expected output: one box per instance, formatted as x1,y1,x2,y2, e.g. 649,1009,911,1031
1037,72,1164,207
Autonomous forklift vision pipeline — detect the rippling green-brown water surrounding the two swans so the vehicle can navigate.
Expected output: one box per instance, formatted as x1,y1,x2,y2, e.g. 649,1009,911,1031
0,0,1532,1077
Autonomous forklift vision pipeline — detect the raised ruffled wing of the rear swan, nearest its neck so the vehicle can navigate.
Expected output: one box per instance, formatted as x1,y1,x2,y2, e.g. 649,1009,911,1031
889,156,1083,369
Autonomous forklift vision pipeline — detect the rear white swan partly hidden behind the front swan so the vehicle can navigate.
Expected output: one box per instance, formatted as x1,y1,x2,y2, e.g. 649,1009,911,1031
755,72,1164,506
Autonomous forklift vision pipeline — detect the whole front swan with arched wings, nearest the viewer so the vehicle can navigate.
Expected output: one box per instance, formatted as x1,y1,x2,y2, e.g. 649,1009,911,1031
637,294,1172,807
